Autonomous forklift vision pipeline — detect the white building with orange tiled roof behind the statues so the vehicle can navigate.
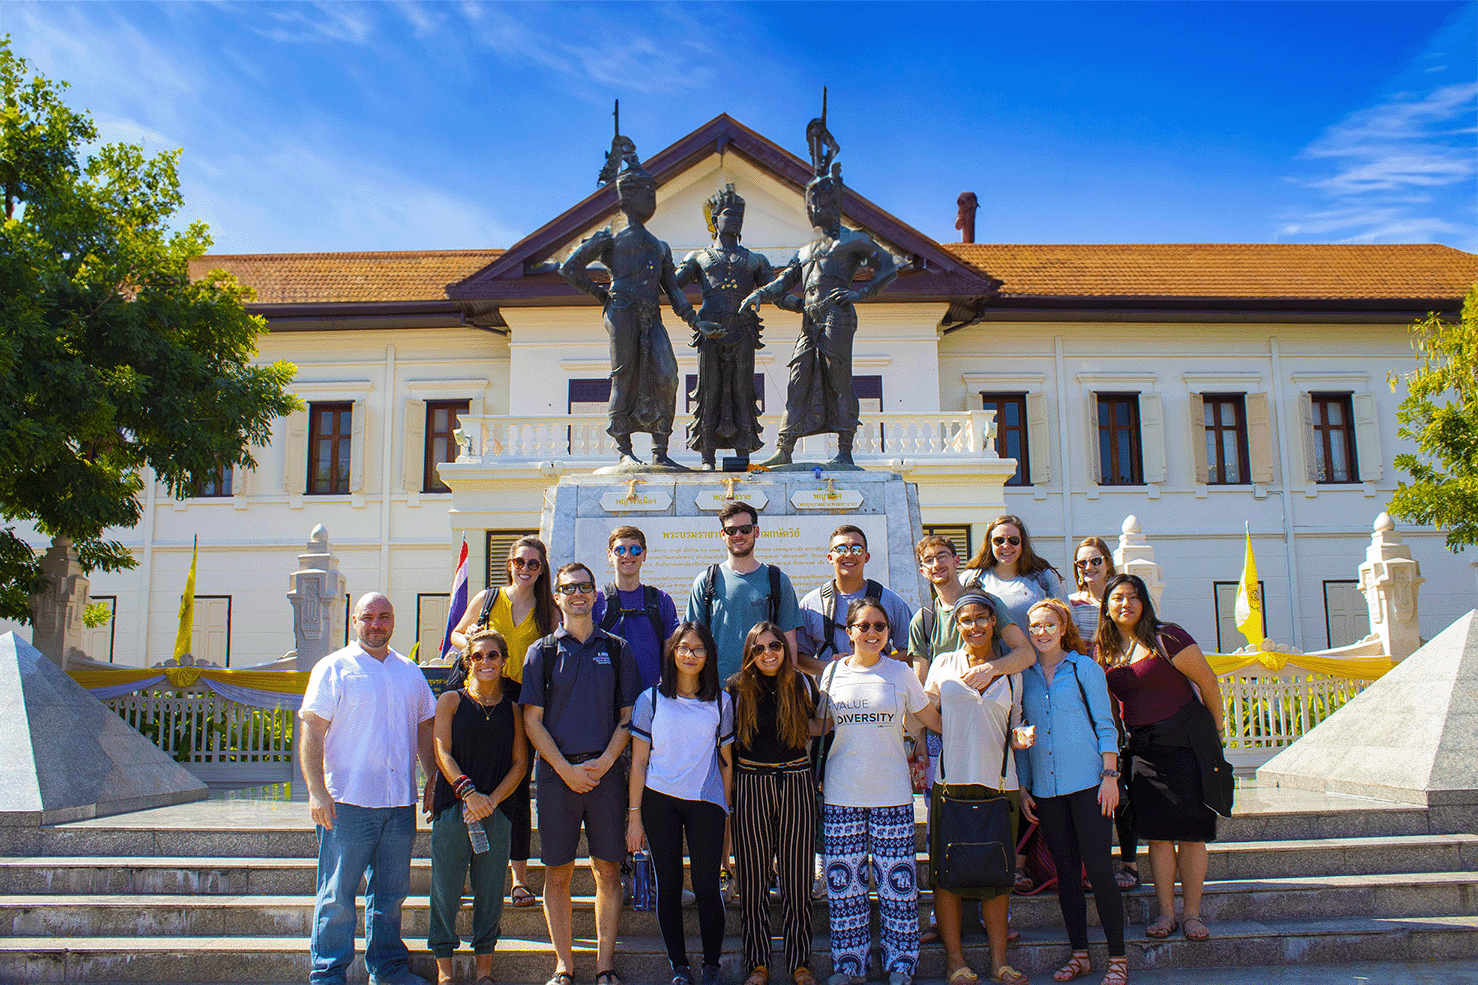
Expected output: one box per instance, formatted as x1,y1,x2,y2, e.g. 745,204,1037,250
14,117,1478,667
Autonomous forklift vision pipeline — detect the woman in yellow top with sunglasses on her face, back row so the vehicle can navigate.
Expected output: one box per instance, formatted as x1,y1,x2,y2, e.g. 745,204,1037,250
448,537,554,907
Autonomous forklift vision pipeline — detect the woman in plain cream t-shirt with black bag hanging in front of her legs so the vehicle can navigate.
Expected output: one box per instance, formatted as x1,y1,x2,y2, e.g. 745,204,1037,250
924,589,1032,985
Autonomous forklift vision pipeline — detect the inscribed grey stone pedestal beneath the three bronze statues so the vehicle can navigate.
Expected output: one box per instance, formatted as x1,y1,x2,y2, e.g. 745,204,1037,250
539,467,928,612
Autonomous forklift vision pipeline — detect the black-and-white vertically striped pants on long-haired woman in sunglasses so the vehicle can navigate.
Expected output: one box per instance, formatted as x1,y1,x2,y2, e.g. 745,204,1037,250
730,760,816,975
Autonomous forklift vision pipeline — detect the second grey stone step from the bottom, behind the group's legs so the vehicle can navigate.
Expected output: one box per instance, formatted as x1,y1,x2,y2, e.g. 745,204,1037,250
0,871,1478,941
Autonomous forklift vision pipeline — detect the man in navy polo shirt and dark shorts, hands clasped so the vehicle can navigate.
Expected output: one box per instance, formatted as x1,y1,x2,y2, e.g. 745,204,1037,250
519,561,641,985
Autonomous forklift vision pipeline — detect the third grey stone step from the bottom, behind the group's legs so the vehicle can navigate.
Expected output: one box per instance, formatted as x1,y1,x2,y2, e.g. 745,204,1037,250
0,834,1478,895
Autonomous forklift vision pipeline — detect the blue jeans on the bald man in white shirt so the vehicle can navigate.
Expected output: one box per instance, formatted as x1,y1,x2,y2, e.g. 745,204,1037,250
307,803,415,985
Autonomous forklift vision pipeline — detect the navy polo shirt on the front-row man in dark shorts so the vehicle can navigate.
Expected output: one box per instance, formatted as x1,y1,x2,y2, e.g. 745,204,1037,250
519,626,641,779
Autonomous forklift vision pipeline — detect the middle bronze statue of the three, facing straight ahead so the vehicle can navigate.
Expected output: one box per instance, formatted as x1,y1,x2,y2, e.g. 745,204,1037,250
677,185,780,470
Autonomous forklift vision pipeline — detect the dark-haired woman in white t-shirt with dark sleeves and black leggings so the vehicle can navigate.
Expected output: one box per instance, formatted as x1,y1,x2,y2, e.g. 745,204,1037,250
627,623,735,985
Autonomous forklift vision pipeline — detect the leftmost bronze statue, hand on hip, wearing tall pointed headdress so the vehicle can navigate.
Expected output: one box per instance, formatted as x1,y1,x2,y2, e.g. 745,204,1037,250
559,151,720,469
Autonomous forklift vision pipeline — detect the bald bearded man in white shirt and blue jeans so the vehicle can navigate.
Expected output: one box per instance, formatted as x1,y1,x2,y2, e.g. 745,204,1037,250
299,592,436,985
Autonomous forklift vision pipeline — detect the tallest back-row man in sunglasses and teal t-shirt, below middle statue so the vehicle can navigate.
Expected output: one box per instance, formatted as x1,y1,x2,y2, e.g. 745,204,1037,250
687,503,801,680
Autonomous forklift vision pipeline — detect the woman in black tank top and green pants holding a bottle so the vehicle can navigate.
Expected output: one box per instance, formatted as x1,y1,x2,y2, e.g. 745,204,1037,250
427,630,528,985
